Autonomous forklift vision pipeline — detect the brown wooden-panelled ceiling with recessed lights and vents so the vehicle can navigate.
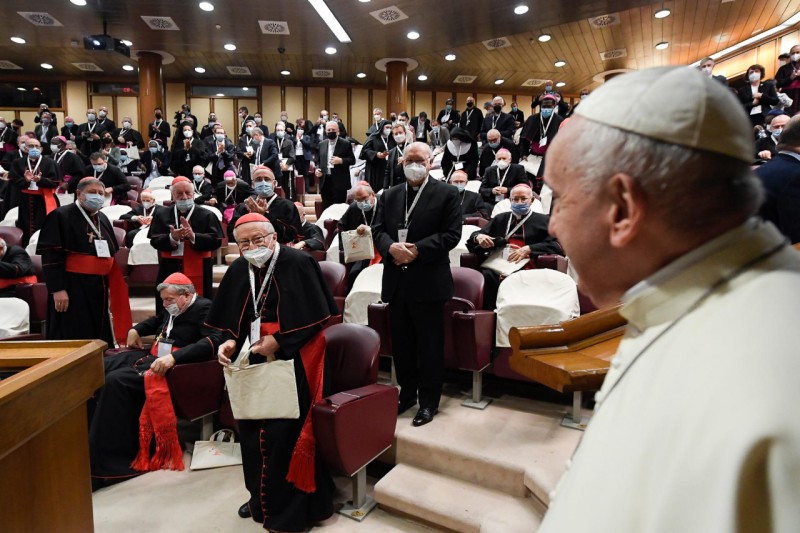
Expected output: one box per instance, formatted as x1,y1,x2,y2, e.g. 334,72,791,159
0,0,800,94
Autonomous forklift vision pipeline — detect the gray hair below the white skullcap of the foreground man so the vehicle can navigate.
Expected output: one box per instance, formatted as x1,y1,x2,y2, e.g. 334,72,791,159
568,120,763,234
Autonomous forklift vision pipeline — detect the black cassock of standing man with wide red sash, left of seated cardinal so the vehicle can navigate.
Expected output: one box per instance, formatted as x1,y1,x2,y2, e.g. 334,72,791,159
36,203,119,347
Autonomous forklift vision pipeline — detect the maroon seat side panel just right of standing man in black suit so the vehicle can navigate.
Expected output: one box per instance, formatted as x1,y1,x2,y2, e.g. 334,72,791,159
452,310,497,371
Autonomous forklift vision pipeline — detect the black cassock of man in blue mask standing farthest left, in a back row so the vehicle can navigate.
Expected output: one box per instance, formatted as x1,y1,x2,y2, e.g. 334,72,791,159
9,156,59,244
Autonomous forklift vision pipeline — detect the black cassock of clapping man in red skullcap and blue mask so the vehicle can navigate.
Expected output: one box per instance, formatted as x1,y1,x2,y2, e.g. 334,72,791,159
147,205,222,309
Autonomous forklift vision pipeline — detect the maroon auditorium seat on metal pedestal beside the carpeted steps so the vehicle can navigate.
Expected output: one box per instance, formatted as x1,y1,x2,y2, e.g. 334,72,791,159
312,324,398,519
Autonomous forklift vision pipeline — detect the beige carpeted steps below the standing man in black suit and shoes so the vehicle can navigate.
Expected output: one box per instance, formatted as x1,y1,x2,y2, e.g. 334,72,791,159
375,388,588,533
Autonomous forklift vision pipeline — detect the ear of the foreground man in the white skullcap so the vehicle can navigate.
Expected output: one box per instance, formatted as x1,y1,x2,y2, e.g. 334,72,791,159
605,173,645,248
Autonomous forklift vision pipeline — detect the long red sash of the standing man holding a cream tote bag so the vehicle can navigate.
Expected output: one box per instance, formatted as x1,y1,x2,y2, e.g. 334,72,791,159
261,322,325,493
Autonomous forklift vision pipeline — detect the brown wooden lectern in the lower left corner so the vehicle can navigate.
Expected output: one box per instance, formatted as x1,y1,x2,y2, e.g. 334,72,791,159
0,340,107,533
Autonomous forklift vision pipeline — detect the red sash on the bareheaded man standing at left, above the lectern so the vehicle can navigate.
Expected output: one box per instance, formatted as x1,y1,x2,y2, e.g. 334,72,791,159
66,253,133,344
